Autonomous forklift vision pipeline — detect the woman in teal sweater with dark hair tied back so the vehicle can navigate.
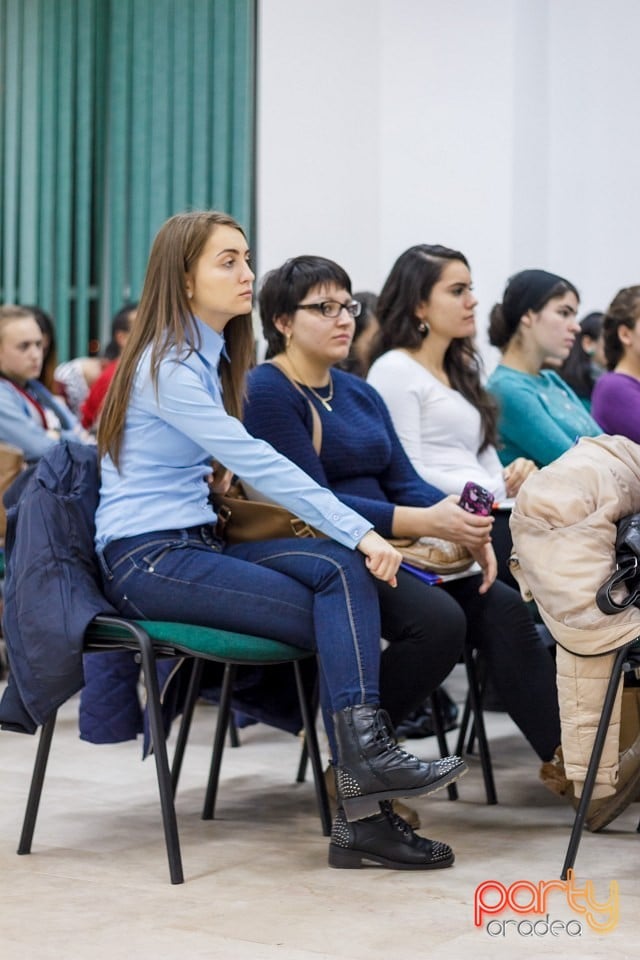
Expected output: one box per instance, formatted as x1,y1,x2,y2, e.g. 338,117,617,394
487,270,602,467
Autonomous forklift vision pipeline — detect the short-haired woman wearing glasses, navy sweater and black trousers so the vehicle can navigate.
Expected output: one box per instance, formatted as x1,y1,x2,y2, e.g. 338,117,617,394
245,257,560,804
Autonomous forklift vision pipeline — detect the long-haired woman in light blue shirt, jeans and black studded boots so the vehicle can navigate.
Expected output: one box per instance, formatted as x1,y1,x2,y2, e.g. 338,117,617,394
96,211,466,870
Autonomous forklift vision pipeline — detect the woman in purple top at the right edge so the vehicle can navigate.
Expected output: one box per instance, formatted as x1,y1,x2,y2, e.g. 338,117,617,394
591,286,640,443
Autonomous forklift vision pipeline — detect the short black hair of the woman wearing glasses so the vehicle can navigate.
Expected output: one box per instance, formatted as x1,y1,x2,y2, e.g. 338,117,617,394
258,255,351,359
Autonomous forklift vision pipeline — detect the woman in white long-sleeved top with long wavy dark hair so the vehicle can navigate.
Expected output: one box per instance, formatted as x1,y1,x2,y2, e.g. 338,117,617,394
368,244,536,586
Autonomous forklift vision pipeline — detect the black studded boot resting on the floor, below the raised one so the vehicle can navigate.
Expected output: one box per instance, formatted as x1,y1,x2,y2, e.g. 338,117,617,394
329,801,455,870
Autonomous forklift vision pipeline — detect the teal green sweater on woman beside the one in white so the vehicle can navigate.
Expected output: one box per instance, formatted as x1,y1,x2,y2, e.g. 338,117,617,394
487,364,602,467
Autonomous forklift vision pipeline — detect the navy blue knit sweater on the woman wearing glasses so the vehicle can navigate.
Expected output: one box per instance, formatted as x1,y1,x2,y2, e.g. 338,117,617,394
244,363,445,537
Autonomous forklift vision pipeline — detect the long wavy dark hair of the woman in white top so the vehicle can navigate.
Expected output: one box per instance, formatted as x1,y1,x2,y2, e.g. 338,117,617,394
372,243,498,451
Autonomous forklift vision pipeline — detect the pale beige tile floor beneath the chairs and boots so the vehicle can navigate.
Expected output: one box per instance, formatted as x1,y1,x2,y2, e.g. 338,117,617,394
0,668,640,960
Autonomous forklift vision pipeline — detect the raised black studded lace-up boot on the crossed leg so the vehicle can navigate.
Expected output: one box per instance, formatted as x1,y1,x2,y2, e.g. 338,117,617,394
333,704,468,820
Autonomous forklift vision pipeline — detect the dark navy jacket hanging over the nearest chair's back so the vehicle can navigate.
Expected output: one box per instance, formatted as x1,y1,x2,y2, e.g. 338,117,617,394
0,441,115,732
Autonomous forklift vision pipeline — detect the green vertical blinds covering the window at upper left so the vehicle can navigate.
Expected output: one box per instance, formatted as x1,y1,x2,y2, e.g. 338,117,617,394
0,0,255,359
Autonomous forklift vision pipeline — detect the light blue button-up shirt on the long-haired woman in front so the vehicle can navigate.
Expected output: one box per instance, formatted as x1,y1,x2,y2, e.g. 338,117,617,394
96,320,372,550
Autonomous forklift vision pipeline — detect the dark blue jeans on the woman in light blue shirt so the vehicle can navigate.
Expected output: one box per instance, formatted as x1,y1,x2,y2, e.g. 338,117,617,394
100,526,380,758
